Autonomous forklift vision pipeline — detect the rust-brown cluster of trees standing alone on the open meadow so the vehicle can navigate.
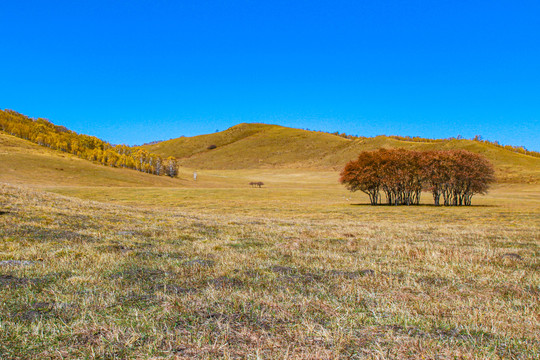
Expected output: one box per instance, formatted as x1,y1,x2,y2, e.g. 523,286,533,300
340,149,495,206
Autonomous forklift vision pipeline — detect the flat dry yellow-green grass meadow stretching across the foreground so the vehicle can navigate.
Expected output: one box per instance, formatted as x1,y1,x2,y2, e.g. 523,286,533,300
0,167,540,359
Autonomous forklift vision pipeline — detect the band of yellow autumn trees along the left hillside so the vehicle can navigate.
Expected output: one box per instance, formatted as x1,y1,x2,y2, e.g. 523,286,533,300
0,110,178,177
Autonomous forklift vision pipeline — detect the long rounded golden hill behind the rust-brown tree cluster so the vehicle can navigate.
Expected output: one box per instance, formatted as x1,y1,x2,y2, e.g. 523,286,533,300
143,124,540,183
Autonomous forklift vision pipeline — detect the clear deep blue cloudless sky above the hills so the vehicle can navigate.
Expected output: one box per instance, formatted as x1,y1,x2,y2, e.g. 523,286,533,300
0,0,540,151
